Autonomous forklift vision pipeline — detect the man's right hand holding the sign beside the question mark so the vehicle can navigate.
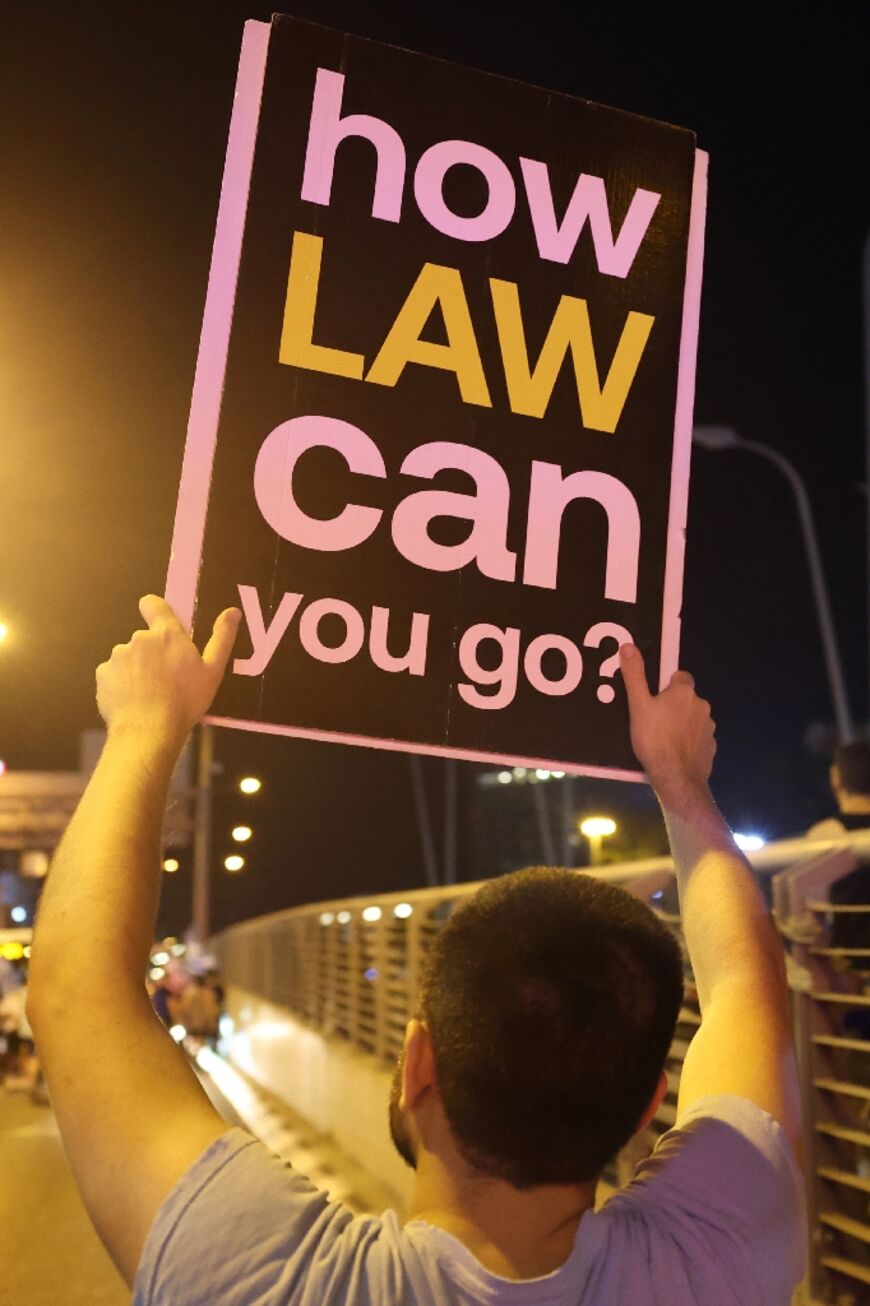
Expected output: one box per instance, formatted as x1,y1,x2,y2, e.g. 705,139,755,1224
619,644,716,815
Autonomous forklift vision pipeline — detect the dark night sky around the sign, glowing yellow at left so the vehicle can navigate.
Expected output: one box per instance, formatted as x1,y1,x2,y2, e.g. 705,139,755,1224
0,0,870,923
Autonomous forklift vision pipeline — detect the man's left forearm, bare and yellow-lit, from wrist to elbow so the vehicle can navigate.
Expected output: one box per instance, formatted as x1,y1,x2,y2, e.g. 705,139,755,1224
30,725,180,1011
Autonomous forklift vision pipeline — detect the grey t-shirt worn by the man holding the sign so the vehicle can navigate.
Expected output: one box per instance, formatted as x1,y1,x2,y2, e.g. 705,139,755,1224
133,1096,806,1306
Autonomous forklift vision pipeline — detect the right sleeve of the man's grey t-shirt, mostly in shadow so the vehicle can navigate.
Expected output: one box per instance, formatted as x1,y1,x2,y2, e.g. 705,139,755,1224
605,1094,807,1306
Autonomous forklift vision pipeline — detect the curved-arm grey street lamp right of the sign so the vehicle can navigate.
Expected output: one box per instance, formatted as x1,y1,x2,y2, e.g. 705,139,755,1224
692,426,854,743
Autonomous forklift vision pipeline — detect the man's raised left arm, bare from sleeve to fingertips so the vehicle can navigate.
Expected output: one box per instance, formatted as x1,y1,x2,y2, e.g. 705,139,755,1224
27,594,239,1282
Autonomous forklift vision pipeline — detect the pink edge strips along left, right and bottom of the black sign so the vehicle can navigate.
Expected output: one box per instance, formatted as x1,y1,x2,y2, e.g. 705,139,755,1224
166,20,708,782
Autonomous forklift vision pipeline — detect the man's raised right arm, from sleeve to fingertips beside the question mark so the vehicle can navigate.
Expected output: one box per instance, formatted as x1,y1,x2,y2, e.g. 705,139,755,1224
620,645,801,1143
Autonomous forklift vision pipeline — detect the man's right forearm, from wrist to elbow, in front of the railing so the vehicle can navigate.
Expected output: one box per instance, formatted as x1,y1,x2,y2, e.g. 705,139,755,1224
662,789,788,1011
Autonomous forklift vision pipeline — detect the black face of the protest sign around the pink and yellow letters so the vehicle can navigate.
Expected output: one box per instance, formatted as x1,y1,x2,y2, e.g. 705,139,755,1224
189,17,695,769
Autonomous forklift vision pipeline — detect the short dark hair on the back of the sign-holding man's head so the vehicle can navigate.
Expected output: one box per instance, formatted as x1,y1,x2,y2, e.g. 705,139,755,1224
419,867,683,1188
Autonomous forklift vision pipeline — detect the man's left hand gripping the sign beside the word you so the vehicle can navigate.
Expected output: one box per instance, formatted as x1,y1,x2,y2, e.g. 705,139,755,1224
97,594,240,737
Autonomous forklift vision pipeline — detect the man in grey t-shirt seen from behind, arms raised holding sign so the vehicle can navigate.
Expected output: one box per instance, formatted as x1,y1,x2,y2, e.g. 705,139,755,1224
29,596,806,1306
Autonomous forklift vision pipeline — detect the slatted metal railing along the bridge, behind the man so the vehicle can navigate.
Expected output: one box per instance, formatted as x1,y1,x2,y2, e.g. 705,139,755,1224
212,829,870,1306
